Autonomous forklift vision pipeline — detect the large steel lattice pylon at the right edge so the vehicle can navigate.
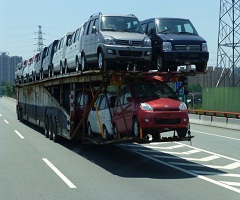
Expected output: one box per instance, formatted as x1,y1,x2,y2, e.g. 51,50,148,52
216,0,240,87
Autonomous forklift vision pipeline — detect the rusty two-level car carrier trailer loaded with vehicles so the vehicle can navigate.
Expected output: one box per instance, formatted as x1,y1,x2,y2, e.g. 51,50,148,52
16,70,196,145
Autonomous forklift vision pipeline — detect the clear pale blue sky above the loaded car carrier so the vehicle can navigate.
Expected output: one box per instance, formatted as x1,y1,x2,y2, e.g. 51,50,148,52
0,0,220,66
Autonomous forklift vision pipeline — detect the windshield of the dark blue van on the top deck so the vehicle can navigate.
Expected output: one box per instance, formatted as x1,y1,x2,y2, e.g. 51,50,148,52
156,19,198,35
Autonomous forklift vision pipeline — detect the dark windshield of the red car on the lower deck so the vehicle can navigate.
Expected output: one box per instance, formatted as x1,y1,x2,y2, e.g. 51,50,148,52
132,83,177,99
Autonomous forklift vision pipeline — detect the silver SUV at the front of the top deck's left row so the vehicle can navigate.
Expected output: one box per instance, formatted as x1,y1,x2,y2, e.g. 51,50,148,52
81,13,152,71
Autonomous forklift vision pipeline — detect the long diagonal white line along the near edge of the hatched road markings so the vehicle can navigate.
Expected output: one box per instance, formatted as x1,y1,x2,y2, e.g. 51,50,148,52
125,148,240,194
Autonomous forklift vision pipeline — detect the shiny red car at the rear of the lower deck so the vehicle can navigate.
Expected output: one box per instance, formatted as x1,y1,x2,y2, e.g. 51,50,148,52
113,81,189,137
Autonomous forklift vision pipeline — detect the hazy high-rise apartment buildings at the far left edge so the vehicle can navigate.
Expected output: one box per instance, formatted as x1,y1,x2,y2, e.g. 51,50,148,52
0,52,22,84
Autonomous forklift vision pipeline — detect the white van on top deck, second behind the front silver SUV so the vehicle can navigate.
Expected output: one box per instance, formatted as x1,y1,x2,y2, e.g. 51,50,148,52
52,32,73,74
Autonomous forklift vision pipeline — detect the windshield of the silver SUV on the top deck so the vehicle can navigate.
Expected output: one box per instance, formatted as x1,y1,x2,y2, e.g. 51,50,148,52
101,16,143,33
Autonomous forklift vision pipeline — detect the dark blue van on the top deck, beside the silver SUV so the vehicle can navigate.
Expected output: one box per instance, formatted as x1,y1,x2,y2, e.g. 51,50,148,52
141,18,209,72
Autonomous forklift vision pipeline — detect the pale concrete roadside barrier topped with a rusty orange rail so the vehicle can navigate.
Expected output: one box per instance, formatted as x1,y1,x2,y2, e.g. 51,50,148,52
189,109,240,130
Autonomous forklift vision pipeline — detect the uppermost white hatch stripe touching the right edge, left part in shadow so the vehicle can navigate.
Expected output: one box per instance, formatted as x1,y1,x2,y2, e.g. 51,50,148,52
170,162,240,169
